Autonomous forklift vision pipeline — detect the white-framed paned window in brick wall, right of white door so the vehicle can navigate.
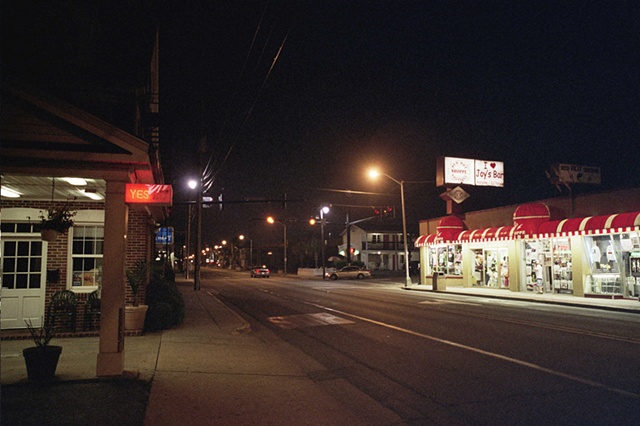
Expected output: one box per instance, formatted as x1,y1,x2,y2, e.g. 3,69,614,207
71,225,104,288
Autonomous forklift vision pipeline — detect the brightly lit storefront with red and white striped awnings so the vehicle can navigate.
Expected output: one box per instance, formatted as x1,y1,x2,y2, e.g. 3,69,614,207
415,189,640,299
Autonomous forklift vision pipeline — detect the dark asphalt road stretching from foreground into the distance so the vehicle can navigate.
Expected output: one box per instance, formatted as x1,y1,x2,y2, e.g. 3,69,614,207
202,269,640,425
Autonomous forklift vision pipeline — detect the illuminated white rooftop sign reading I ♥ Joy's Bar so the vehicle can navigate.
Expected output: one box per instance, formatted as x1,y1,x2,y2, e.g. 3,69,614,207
436,157,504,187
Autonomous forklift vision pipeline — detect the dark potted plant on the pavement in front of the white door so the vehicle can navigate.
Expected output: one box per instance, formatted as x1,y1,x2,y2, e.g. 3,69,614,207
22,320,62,382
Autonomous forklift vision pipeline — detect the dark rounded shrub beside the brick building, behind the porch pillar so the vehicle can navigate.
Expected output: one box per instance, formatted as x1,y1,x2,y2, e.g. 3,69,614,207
144,262,185,331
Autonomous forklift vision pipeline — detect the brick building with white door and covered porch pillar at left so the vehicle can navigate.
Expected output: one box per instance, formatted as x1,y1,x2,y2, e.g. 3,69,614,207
0,22,167,376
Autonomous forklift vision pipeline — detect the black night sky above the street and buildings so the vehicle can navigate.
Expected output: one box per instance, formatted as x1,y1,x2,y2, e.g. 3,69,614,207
2,0,640,248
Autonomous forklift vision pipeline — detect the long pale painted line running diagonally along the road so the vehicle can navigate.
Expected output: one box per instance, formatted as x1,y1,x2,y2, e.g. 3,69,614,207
306,302,640,400
